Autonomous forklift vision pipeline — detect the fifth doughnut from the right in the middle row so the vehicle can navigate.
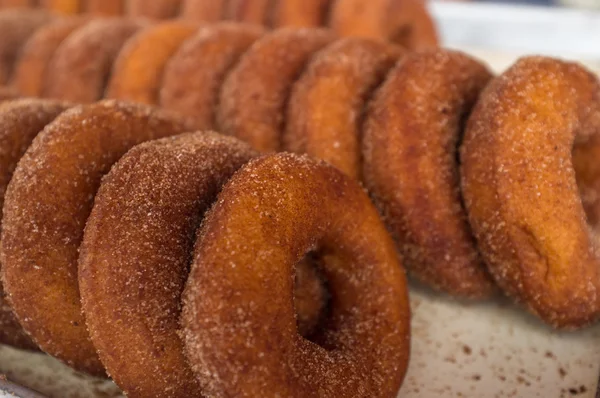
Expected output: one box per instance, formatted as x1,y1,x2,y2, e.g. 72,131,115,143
160,22,263,130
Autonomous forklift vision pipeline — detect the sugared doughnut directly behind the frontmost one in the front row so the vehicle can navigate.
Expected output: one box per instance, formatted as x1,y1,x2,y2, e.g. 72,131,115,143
79,133,254,397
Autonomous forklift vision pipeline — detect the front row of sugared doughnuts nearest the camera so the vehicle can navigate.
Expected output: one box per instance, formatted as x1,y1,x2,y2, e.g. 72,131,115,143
0,99,410,397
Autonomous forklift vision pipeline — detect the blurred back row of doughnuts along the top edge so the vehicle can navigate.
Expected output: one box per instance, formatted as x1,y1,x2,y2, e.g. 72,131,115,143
0,0,438,49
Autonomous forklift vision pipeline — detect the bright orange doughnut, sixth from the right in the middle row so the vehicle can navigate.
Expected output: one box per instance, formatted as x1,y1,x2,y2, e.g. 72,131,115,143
106,21,198,105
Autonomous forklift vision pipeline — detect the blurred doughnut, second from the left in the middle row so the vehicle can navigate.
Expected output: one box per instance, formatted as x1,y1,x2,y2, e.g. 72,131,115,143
13,17,88,97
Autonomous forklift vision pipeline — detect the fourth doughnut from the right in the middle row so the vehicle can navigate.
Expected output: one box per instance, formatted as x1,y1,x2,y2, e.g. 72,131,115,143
217,28,333,152
